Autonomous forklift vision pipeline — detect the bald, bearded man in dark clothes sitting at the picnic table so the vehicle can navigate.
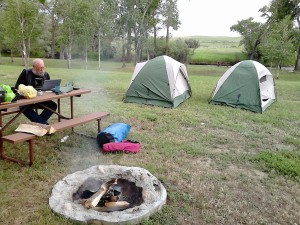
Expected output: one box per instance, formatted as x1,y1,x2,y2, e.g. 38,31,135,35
15,59,57,124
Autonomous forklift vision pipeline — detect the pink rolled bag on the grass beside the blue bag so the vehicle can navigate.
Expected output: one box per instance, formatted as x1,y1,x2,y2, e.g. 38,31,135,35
102,140,141,153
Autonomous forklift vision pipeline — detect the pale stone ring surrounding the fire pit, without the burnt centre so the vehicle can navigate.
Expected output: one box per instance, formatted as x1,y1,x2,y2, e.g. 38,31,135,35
49,165,167,225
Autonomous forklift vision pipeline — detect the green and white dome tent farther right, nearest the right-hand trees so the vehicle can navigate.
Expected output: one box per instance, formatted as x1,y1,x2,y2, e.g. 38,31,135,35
209,60,276,113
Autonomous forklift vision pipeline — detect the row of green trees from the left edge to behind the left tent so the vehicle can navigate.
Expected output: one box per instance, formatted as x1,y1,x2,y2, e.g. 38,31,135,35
0,0,188,68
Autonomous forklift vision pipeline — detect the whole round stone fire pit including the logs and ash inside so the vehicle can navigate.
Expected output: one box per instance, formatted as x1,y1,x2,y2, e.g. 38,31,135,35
49,165,167,224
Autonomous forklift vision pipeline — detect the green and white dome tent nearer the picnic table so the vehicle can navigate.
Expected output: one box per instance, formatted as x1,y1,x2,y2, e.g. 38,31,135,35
123,55,192,108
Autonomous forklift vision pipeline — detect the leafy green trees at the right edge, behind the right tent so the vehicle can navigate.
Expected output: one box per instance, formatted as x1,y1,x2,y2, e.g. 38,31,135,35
230,0,300,72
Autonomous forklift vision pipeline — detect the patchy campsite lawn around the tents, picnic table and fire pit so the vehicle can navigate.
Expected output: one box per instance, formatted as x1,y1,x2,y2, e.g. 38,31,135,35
0,58,300,225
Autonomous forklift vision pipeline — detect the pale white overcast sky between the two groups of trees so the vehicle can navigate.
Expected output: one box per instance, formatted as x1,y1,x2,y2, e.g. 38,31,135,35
166,0,271,37
